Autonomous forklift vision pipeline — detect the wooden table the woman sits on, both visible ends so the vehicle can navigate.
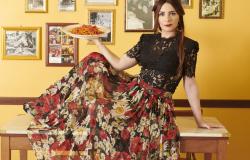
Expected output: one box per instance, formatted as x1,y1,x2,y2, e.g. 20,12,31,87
0,115,230,160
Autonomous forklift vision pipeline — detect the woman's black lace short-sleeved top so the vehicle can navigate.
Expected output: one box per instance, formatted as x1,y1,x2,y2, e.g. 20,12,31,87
126,34,199,93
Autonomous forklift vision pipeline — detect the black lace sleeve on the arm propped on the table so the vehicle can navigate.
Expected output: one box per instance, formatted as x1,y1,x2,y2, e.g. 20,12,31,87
183,42,199,77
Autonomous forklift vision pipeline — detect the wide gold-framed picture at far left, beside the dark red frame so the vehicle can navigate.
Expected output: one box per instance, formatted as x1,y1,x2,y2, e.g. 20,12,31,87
2,27,41,60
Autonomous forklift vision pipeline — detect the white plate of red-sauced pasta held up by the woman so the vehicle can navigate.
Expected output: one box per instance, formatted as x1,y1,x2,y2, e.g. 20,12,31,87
61,24,110,39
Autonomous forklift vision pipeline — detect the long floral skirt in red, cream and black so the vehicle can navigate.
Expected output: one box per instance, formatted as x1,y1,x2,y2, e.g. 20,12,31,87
24,52,179,160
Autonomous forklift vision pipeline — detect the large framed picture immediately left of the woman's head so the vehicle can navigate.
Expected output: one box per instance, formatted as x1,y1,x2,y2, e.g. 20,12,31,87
125,0,154,32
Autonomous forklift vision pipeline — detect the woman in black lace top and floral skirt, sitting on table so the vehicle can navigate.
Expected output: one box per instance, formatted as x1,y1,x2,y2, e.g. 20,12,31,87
24,0,215,160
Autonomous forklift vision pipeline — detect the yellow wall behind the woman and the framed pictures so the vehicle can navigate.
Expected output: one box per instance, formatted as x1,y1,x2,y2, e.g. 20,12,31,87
0,0,250,160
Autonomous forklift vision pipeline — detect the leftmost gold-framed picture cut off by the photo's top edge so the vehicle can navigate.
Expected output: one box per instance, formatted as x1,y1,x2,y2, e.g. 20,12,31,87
25,0,48,13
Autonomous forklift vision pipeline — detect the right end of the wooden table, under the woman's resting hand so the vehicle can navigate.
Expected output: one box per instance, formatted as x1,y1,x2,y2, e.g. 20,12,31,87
176,117,230,160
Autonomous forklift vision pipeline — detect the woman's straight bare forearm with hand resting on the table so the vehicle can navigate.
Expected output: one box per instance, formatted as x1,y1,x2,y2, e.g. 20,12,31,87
183,76,213,129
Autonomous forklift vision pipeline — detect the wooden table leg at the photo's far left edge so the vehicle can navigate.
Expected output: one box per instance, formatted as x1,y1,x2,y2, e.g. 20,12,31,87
1,136,11,160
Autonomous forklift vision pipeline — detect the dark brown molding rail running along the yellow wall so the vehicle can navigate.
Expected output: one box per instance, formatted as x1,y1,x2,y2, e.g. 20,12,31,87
0,97,250,108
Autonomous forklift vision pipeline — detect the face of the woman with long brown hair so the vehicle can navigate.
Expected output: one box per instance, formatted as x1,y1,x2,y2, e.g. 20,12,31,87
159,2,179,34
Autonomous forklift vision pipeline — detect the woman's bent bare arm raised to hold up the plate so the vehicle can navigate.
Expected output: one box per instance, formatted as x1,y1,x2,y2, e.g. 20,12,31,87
92,39,137,71
